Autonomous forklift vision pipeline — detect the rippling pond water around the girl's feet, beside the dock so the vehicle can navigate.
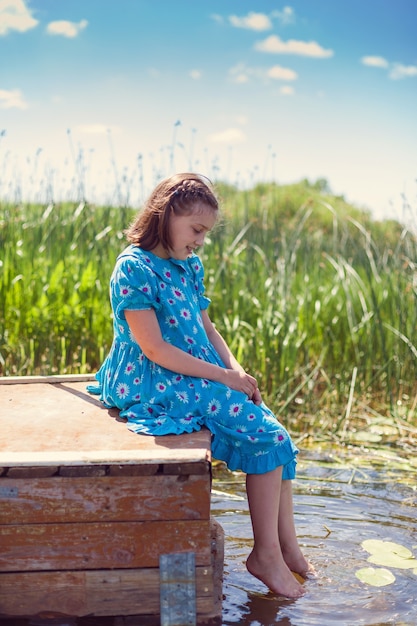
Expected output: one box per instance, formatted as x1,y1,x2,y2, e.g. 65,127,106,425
212,456,417,626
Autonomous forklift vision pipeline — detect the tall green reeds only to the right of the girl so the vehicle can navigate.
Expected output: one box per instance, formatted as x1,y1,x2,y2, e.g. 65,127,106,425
207,186,417,426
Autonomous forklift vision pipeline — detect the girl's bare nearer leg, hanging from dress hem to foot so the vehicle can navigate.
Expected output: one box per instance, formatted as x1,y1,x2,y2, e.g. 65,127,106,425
246,467,303,598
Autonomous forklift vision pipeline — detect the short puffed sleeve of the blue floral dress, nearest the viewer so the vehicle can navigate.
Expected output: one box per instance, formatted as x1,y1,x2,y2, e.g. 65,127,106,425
110,257,160,320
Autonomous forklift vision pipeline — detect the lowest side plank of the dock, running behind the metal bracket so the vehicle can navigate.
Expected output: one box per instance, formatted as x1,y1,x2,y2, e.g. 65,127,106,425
0,566,213,617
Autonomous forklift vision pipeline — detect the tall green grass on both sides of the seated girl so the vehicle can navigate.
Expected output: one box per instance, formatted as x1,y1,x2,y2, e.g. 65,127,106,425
0,184,417,431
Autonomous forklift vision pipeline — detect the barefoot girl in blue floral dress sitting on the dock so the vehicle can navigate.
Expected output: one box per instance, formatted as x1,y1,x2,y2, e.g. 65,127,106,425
89,173,309,598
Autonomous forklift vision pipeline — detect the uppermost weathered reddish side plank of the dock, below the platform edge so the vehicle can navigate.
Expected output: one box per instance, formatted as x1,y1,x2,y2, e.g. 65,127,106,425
0,476,210,524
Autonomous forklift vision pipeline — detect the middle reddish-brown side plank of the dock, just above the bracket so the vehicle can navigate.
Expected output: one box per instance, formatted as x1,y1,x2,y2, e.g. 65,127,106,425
0,520,211,572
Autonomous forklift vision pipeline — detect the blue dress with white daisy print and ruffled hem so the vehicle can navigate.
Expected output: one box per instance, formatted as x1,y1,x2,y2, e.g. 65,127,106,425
88,245,298,479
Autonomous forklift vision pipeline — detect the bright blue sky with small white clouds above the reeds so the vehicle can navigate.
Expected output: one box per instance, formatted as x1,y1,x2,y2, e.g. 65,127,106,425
0,0,417,219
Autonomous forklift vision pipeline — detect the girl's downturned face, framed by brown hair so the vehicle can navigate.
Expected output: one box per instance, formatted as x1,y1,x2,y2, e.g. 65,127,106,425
169,204,217,261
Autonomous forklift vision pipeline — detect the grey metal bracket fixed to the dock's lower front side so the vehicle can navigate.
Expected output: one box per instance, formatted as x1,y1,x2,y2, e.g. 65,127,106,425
159,552,197,626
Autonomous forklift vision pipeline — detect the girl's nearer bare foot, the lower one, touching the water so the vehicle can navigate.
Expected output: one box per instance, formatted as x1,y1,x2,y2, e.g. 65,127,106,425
246,550,305,598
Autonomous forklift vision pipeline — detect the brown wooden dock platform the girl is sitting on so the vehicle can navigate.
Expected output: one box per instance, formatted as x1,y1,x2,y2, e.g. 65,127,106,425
0,376,224,626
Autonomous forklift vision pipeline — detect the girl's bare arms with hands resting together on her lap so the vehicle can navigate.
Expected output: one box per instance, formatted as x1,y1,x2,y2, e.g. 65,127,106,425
125,309,259,401
